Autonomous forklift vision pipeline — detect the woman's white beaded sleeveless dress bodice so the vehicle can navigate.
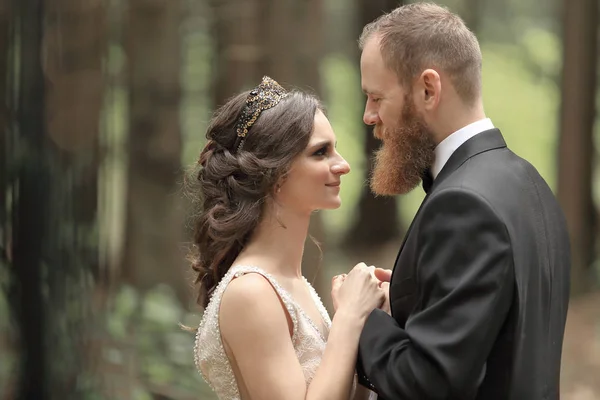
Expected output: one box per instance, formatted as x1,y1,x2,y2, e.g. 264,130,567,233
194,266,331,400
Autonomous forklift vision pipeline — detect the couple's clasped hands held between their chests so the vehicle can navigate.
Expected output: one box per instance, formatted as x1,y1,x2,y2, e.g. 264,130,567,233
331,263,392,315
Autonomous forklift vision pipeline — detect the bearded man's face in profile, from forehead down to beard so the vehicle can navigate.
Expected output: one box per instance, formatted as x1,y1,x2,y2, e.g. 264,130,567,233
360,37,435,195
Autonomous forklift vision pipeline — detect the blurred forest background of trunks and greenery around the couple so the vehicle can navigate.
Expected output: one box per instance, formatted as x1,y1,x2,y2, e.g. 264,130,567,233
0,0,600,400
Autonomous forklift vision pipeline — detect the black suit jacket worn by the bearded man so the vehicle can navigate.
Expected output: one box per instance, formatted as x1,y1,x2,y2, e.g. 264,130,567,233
358,129,570,400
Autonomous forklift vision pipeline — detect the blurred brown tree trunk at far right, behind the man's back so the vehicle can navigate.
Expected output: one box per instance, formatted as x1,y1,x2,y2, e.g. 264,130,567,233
558,0,598,295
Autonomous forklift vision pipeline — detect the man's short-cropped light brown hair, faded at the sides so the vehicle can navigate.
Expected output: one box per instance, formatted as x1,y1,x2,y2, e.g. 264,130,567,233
359,3,481,105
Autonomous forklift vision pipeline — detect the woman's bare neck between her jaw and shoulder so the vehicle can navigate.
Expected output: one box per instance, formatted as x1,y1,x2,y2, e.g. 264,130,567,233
235,207,310,278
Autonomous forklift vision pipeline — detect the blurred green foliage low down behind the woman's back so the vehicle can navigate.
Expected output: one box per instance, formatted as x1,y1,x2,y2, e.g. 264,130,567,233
104,285,216,399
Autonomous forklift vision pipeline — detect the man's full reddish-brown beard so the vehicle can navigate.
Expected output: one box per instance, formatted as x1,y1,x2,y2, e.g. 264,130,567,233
371,95,436,196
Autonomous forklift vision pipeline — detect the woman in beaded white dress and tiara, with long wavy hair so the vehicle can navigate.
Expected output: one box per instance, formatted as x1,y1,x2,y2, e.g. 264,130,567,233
193,77,385,400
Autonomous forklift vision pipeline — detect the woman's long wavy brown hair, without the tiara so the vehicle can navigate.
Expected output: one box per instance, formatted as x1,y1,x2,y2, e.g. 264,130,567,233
189,91,322,308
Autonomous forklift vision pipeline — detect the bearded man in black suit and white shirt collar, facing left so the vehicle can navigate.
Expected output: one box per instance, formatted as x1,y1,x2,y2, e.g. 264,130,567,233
358,3,570,400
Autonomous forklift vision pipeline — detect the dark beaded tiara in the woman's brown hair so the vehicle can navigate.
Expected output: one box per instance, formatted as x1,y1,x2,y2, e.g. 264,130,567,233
233,76,288,152
